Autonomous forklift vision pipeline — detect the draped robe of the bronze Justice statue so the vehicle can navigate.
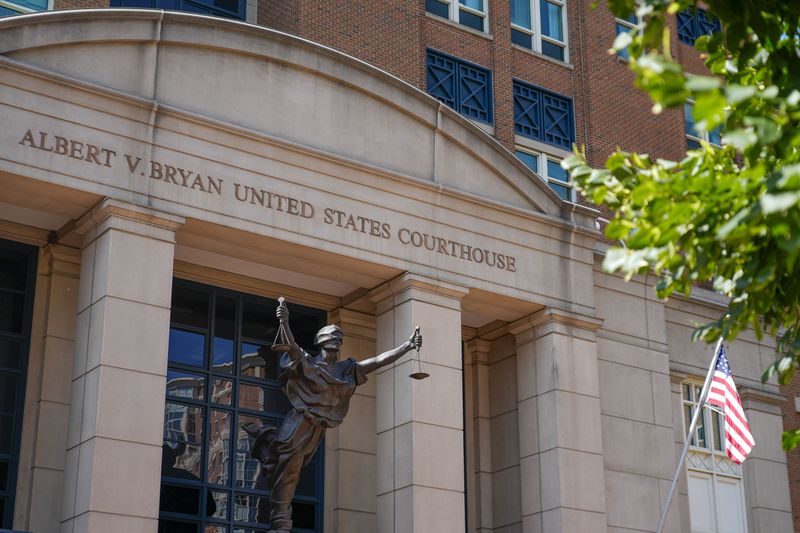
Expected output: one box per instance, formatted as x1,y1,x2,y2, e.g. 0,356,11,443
252,351,367,531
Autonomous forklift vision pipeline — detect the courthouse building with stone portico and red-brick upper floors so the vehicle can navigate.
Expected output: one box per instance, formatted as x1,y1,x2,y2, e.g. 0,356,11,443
0,4,792,533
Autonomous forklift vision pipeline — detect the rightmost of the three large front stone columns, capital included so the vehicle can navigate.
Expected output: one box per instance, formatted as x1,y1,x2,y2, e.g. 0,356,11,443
509,308,606,533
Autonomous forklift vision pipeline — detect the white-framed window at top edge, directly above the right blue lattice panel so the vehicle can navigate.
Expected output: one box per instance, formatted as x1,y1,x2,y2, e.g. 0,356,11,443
511,0,569,62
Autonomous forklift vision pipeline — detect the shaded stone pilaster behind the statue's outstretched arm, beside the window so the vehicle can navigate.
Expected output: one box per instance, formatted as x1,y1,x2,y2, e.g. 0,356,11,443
325,309,377,533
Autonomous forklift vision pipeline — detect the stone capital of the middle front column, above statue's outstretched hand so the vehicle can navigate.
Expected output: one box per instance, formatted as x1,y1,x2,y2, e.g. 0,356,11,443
367,272,469,314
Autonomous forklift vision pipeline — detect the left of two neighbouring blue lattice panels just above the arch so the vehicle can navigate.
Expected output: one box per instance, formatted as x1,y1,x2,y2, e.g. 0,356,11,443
425,50,494,124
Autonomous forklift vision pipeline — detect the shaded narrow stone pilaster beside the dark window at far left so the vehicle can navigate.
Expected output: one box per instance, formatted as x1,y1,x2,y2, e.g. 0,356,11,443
22,244,80,531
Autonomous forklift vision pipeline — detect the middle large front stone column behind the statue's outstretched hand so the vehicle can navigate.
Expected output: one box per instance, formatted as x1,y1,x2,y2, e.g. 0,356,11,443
370,273,467,533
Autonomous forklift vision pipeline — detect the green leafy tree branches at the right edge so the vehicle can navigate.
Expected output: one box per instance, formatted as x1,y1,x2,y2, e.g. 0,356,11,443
563,0,800,448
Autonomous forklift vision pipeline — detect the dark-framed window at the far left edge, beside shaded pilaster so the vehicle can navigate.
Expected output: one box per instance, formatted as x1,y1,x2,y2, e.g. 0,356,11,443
0,240,38,529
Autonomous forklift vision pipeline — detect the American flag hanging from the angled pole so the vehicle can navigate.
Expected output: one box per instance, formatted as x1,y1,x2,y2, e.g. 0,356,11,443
708,347,756,464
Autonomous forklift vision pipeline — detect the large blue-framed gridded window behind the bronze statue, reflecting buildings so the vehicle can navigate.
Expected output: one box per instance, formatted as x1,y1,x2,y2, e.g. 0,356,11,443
158,280,325,533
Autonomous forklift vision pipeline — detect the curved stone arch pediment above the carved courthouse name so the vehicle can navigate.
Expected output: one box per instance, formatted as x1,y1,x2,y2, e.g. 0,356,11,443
0,9,590,225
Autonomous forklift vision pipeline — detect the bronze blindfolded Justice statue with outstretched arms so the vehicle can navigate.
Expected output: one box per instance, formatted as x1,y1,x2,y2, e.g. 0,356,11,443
244,298,422,533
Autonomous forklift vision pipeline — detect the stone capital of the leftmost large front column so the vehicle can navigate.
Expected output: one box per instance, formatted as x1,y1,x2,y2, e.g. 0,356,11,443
75,198,186,246
